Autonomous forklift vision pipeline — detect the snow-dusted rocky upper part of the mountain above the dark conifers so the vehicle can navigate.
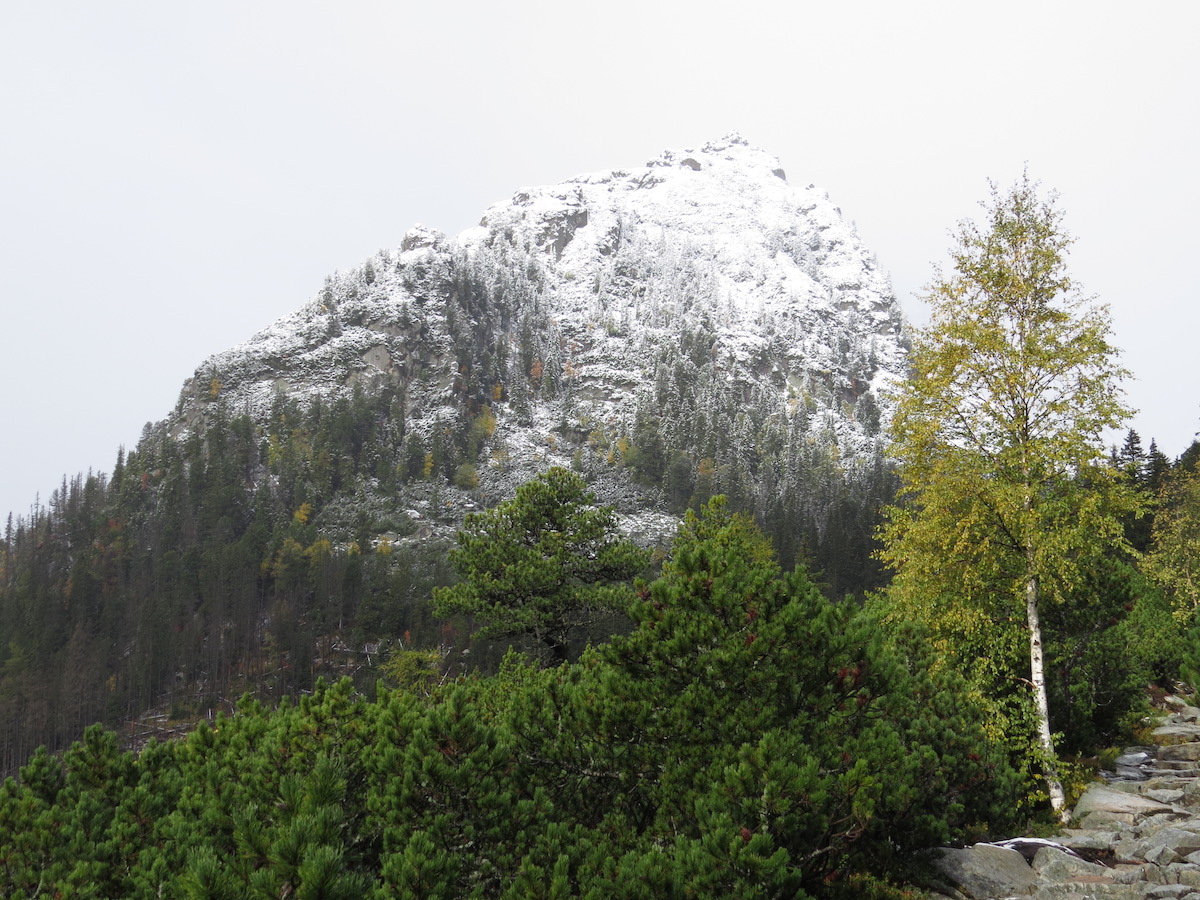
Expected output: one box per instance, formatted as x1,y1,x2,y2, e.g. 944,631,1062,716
179,136,905,440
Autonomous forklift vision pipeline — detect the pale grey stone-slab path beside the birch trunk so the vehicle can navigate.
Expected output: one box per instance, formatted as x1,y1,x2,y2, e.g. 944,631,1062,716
929,698,1200,900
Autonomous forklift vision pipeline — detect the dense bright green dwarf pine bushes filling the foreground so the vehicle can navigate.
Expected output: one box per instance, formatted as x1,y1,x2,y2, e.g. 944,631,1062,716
0,503,1014,899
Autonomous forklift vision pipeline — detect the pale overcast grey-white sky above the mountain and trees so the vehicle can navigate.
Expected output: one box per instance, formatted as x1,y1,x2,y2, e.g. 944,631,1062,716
0,0,1200,517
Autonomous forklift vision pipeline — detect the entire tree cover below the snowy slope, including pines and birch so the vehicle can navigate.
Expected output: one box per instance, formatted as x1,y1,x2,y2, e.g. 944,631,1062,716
0,179,1200,898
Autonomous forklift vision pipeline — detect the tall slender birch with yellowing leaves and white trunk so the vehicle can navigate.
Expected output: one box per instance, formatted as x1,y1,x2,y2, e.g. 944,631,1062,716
881,174,1138,815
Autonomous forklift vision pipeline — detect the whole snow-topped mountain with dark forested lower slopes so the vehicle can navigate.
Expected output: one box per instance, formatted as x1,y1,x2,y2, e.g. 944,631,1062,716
0,136,906,770
